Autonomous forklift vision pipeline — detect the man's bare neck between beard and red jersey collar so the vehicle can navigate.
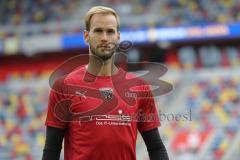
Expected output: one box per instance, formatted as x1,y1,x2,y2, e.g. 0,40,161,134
87,56,118,76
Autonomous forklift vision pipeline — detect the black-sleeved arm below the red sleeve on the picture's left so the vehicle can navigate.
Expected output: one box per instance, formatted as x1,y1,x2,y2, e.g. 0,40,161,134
42,126,66,160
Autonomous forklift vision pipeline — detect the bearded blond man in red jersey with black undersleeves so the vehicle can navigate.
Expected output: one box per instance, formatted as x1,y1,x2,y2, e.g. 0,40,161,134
42,6,168,160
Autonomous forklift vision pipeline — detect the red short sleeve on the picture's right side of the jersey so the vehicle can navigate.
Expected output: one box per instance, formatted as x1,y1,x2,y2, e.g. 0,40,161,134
137,84,160,132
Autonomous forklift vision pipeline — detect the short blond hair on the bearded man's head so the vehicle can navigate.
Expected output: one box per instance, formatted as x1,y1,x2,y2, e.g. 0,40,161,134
85,6,120,31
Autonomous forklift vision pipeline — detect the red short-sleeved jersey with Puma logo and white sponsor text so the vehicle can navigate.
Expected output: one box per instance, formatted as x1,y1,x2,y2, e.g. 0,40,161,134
45,67,160,160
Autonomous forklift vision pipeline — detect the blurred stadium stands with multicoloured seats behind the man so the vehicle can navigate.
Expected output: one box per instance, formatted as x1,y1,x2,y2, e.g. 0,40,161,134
0,0,240,160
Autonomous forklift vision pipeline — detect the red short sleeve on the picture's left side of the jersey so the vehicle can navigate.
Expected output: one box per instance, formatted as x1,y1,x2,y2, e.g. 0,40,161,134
45,79,68,128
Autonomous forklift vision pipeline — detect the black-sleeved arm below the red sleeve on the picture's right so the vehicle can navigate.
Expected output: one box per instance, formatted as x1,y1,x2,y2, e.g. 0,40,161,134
141,128,169,160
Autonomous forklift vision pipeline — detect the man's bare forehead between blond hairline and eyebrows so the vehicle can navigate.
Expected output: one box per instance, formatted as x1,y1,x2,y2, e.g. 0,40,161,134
90,14,117,30
